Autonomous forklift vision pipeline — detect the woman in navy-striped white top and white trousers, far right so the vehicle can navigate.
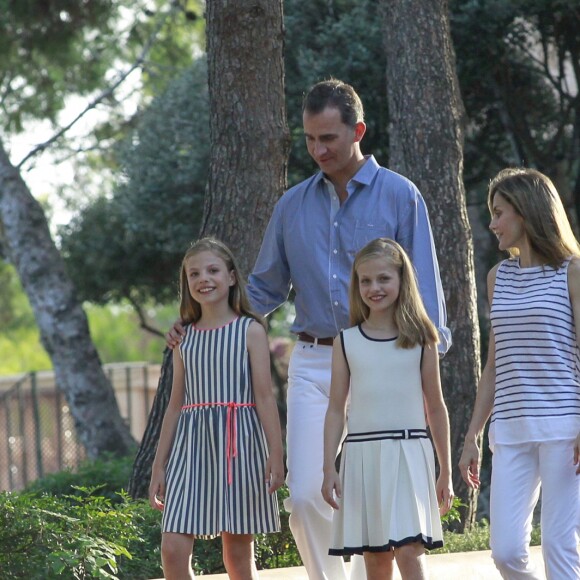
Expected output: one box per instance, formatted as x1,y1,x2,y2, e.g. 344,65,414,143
460,169,580,580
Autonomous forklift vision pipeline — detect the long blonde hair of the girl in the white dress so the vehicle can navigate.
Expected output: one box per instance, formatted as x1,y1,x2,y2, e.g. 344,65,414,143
349,238,439,348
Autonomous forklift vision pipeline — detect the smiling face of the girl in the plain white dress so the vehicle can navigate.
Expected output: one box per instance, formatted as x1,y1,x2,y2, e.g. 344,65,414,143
357,258,401,315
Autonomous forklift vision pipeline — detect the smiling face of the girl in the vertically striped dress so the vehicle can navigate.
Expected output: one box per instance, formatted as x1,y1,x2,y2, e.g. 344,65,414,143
185,251,236,305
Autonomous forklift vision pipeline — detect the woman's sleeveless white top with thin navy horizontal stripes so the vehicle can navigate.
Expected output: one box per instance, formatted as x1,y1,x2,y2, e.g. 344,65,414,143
489,259,580,448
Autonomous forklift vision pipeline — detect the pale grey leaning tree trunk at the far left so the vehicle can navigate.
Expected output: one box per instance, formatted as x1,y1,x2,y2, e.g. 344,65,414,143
0,143,135,458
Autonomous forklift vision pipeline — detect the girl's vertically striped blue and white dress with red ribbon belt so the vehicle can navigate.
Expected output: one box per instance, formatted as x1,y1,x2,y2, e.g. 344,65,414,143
162,317,280,538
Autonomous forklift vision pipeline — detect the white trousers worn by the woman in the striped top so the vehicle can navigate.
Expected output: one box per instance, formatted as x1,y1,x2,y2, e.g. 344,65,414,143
490,440,580,580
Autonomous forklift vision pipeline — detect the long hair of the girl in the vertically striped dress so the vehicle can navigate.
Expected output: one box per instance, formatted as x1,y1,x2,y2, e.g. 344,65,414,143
179,237,264,324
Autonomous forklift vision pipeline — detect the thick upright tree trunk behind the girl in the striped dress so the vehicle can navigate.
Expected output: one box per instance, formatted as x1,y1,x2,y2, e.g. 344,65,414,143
129,0,290,497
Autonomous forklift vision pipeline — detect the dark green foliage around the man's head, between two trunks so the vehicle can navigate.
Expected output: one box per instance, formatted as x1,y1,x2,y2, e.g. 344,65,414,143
284,0,388,183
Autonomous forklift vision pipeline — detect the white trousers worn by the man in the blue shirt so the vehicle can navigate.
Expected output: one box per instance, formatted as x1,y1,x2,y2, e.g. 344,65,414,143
284,341,366,580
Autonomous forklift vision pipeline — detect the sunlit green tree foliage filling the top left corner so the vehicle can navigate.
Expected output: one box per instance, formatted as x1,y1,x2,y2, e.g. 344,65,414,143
0,0,203,133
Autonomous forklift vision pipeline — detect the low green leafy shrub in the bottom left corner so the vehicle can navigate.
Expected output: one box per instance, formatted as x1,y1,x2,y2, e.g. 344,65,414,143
0,488,155,580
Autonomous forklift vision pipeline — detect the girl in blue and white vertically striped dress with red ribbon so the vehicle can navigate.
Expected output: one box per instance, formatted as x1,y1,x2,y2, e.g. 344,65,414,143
149,238,284,580
